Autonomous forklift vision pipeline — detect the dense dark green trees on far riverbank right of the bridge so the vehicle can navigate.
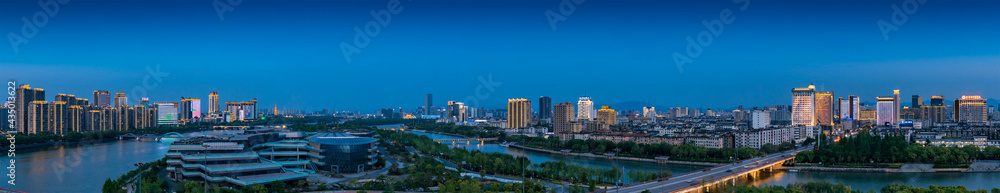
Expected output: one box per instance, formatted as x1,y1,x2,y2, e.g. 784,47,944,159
796,130,1000,165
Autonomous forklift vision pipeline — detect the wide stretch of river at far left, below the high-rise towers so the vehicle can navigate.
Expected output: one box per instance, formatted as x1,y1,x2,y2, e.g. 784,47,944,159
0,130,242,193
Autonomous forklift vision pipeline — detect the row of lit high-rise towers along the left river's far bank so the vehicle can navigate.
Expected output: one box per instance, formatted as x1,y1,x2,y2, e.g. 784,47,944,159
0,84,259,135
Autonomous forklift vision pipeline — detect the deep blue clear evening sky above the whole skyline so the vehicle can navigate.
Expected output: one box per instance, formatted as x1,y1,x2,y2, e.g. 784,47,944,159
0,0,1000,112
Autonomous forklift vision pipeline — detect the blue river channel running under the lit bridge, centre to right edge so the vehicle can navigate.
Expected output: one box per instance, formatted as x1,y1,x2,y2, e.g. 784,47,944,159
411,131,1000,192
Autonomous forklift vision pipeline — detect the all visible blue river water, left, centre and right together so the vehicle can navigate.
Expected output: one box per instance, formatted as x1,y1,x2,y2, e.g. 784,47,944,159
0,131,1000,193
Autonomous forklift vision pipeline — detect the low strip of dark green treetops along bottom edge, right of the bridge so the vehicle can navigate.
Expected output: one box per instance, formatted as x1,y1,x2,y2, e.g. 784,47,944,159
726,181,1000,193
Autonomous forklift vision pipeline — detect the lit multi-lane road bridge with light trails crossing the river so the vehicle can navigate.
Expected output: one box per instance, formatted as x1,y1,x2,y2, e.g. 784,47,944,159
599,146,812,193
